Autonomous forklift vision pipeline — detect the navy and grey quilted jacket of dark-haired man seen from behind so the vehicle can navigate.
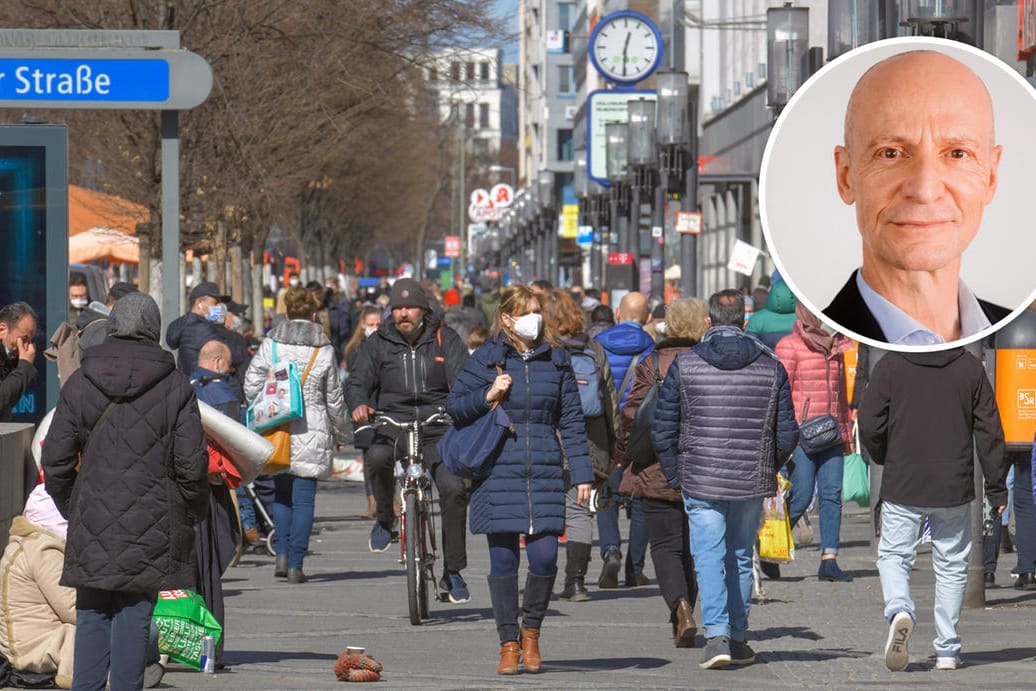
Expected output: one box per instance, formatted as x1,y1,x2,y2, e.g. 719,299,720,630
652,326,799,501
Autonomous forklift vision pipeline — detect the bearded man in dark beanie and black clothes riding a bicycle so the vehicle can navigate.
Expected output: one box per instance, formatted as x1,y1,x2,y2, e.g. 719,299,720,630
345,279,470,603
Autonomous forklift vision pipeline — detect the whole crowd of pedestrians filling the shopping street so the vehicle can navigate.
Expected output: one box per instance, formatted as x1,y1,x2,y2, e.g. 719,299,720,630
0,269,1019,689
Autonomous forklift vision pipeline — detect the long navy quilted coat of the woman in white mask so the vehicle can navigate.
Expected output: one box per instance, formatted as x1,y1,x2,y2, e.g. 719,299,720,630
447,339,594,535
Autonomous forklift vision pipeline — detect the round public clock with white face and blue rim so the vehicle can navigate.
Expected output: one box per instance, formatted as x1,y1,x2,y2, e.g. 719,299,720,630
589,9,663,85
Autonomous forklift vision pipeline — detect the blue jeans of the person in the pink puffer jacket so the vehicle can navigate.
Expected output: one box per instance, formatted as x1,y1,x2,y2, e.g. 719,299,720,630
787,445,844,554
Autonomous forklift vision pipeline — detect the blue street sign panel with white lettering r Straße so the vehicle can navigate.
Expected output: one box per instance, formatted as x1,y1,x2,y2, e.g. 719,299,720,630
0,58,169,103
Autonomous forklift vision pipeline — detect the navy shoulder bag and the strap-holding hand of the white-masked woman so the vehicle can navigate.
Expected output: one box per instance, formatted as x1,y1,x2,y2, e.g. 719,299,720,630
435,365,514,480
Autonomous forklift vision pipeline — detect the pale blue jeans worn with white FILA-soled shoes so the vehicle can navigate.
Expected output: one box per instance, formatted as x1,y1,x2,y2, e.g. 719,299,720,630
877,500,972,657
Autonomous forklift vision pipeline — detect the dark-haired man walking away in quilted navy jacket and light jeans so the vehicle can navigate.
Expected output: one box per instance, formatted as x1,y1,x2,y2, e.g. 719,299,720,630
652,290,799,669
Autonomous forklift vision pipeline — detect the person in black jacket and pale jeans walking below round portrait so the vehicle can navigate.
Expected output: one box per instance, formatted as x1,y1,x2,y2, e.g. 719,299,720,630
859,348,1008,671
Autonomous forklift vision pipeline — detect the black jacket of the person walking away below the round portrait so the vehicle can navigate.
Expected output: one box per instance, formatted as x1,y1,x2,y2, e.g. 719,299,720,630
858,348,1008,507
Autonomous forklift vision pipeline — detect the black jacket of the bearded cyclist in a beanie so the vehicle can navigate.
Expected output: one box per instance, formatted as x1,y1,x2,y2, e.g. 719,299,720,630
345,314,467,433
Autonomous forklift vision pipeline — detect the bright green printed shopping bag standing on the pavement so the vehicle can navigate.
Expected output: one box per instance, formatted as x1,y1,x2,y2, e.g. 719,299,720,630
151,589,223,670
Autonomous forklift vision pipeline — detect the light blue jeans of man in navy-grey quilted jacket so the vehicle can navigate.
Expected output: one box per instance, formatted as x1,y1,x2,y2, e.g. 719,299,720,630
684,494,762,641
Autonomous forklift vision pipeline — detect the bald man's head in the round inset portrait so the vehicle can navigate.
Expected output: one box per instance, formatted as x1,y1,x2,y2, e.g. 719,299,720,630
835,53,1001,272
